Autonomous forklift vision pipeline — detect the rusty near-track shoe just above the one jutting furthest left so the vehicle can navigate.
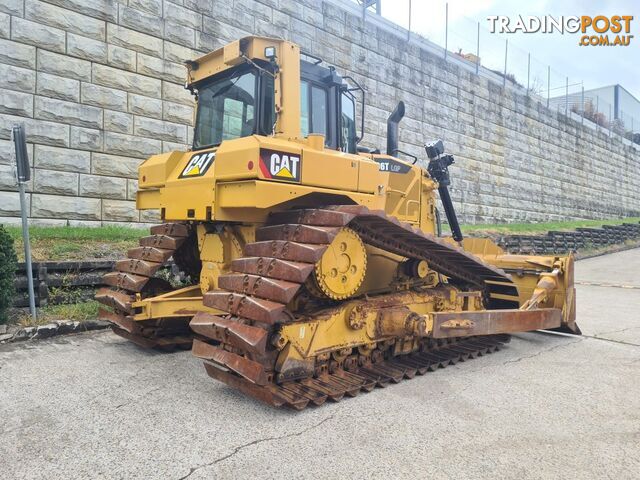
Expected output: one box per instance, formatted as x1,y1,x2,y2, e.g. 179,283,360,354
203,290,285,325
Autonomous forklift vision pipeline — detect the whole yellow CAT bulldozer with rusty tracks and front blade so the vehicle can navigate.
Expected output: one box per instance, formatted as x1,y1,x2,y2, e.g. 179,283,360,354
96,37,579,409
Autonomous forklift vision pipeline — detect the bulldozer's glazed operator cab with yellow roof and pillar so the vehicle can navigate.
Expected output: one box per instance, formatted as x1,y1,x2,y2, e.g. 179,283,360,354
187,37,358,153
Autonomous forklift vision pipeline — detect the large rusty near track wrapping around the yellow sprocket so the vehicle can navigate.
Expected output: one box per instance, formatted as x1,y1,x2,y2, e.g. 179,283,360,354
191,206,517,409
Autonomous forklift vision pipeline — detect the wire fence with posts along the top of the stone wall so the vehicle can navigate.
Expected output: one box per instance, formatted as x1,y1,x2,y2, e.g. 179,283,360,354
352,0,640,144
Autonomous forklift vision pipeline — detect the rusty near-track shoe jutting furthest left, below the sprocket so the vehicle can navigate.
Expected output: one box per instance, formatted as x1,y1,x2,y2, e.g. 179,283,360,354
189,312,268,354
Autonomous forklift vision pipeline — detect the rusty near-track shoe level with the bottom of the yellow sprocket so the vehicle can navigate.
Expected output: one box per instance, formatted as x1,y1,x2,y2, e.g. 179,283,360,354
218,273,300,304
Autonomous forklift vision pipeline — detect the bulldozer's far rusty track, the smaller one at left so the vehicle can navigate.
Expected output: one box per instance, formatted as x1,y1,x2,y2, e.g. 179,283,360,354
95,223,192,350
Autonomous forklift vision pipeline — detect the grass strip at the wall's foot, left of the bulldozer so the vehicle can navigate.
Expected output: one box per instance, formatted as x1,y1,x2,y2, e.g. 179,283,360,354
7,226,145,262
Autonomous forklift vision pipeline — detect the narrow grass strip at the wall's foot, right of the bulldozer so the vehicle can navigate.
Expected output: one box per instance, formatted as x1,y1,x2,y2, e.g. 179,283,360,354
458,217,640,235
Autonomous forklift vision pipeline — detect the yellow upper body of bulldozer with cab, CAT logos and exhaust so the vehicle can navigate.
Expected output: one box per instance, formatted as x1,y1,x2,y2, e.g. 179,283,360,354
137,37,424,227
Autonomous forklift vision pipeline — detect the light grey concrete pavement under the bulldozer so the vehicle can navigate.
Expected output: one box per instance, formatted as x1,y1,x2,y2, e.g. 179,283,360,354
0,249,640,480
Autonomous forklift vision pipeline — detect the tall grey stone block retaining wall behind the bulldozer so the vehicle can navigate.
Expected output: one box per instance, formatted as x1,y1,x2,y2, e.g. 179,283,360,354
0,0,640,225
